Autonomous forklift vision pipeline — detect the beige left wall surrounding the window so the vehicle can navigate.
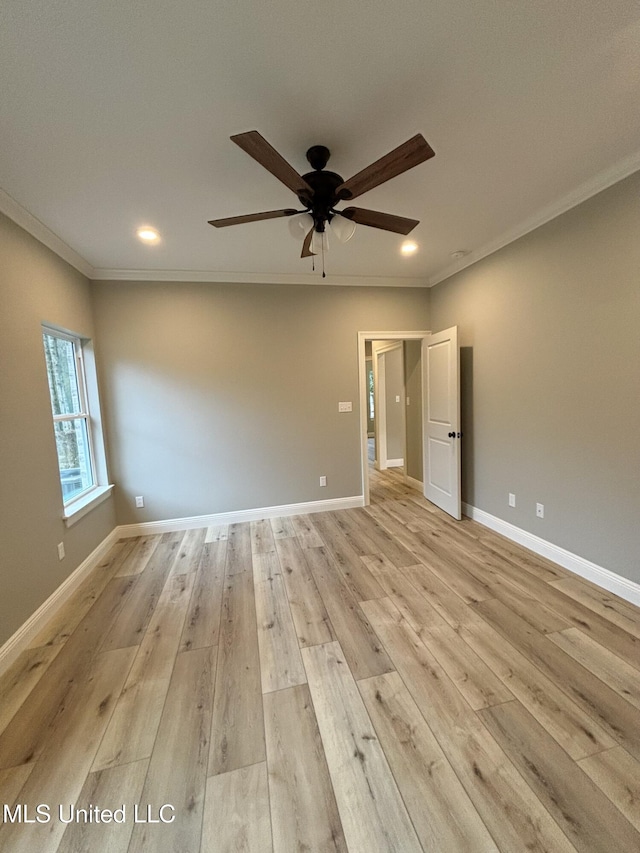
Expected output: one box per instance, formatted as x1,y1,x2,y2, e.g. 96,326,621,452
0,215,115,645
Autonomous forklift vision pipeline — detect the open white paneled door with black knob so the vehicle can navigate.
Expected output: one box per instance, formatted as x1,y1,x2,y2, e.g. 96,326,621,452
422,326,462,519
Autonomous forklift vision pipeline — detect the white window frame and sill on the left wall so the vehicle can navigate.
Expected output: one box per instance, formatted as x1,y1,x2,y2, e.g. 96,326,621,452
42,323,113,526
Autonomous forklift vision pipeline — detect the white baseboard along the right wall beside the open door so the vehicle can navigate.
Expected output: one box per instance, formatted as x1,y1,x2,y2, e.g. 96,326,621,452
462,504,640,607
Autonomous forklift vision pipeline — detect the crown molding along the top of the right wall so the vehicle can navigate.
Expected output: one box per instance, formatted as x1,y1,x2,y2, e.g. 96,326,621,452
427,151,640,287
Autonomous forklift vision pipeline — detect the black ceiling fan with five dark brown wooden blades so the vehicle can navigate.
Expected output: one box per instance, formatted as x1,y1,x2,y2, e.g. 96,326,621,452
209,130,435,258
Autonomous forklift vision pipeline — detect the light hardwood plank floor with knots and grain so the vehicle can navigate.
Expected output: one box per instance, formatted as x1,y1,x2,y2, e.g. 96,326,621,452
0,470,640,853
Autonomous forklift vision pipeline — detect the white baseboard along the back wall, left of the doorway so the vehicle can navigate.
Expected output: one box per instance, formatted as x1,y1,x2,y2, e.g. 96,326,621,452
118,495,364,537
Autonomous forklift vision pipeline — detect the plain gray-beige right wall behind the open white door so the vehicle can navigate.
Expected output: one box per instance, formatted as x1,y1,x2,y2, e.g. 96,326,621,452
431,173,640,581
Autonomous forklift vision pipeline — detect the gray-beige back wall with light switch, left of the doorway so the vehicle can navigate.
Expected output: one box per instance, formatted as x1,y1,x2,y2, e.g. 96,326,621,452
93,282,429,523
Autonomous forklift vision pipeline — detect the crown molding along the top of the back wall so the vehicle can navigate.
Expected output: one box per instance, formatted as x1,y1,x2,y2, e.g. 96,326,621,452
92,269,428,287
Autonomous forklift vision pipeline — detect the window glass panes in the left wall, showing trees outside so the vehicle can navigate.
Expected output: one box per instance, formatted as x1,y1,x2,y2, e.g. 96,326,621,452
43,329,96,505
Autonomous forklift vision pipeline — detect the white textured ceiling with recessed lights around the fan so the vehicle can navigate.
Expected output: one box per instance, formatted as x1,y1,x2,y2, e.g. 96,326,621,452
0,0,640,284
